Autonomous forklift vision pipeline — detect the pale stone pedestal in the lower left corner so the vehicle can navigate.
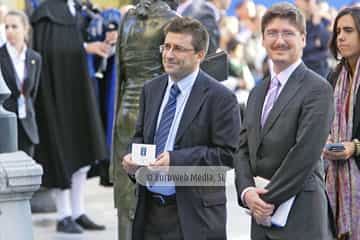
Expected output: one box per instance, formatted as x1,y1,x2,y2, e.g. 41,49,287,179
0,152,43,240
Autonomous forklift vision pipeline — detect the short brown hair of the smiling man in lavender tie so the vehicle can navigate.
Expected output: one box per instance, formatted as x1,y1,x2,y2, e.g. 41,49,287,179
261,2,306,34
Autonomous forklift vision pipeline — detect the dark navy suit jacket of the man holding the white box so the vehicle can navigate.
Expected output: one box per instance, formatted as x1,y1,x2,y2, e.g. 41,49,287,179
133,71,240,240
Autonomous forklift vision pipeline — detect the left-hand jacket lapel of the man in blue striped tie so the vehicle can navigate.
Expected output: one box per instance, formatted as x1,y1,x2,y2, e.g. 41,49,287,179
148,75,168,142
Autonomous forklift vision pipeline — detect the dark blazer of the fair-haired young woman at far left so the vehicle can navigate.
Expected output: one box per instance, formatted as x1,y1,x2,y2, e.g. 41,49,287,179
0,45,41,144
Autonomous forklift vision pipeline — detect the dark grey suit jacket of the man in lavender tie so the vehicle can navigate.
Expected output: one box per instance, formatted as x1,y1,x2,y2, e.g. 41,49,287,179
235,64,334,240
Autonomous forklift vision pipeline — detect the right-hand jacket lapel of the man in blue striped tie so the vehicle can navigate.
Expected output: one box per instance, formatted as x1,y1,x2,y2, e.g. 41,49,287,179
175,70,208,144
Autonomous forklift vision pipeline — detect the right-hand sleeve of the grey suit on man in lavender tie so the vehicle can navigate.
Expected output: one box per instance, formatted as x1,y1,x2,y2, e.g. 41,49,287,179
262,81,334,205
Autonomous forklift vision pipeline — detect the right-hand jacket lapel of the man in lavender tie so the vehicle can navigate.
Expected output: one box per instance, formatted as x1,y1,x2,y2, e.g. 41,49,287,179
261,63,306,139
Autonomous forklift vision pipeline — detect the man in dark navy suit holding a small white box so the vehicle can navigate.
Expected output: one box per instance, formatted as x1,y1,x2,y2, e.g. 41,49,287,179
122,17,240,240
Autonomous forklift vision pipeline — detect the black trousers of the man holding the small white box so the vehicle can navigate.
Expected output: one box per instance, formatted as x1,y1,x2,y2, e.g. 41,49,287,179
144,193,184,240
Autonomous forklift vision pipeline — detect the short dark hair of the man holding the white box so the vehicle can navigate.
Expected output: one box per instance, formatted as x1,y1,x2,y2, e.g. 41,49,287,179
164,17,209,54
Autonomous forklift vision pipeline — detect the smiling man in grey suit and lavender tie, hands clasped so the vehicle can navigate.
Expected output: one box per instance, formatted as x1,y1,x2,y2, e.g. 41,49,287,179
234,3,334,240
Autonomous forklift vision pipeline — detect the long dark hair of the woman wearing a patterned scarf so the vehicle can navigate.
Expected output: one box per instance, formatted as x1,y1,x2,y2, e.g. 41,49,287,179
329,7,360,60
